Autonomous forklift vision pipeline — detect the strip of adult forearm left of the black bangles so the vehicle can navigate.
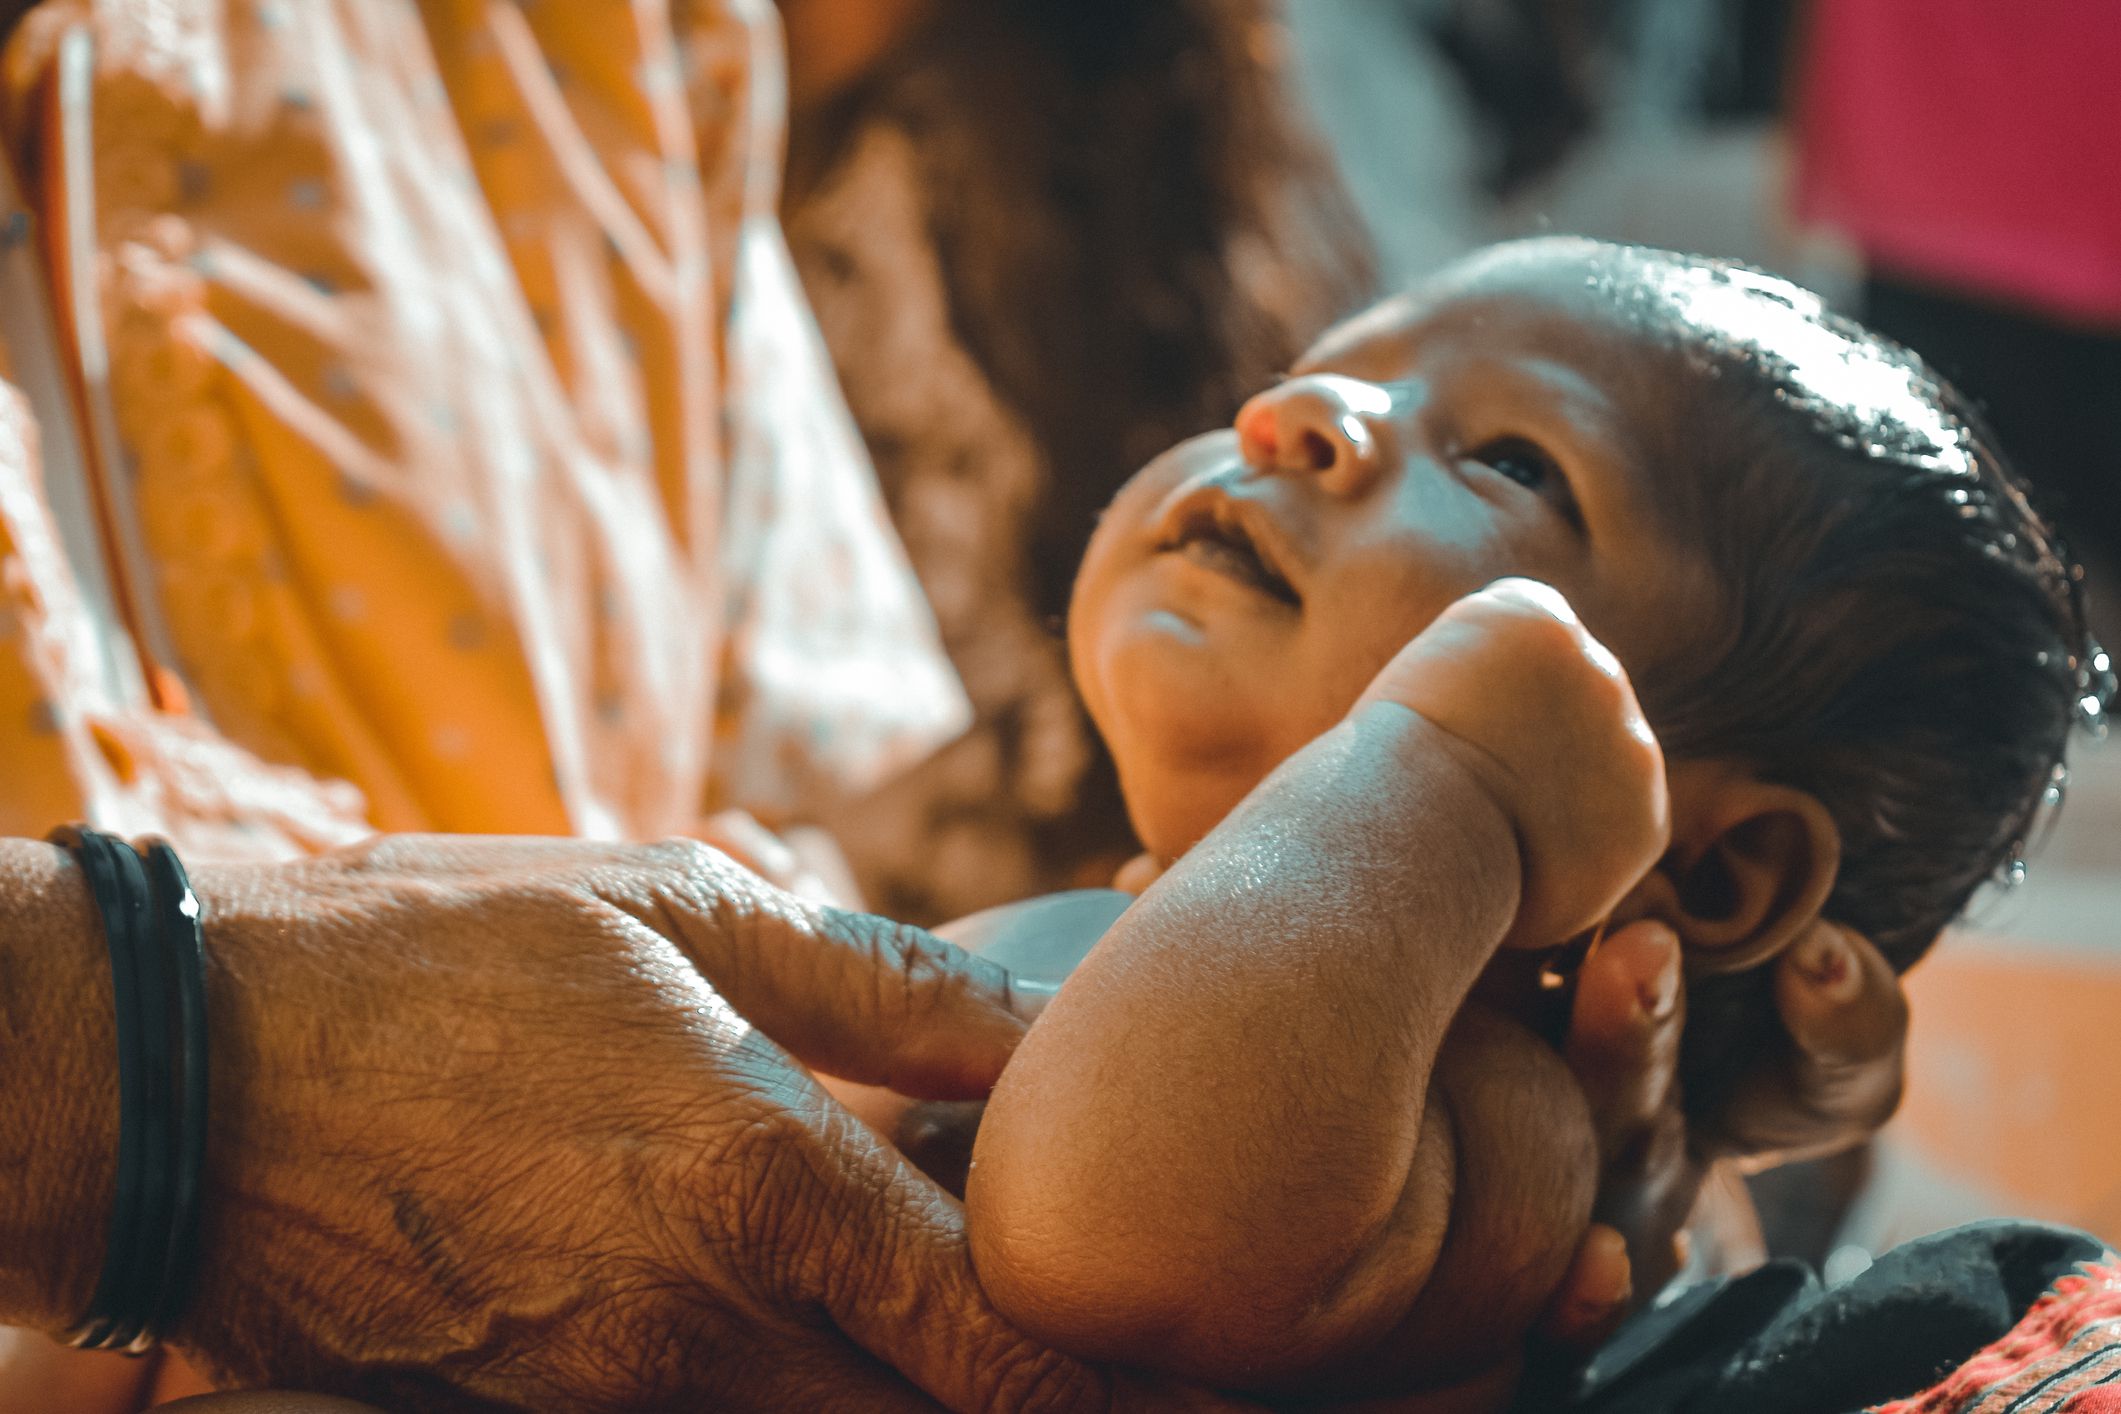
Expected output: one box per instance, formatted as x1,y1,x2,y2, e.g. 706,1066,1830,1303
0,839,117,1329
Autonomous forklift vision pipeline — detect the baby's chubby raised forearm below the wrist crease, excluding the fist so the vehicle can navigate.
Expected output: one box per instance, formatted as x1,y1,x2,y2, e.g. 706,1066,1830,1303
969,704,1521,1356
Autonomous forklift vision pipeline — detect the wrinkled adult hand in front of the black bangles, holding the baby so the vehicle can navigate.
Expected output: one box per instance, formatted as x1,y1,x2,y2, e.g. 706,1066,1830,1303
176,837,1247,1410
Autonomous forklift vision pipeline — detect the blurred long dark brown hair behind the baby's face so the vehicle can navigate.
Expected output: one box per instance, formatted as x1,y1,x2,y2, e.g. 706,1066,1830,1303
789,0,1377,615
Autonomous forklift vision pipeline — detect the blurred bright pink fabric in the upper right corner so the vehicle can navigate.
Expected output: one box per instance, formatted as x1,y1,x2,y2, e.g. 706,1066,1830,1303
1799,0,2121,324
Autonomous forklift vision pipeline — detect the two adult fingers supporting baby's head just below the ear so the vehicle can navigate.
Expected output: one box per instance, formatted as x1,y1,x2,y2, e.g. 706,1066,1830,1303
1567,922,1907,1297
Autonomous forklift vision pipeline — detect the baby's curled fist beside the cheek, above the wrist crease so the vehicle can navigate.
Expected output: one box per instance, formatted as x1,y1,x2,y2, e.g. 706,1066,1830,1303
1355,579,1671,948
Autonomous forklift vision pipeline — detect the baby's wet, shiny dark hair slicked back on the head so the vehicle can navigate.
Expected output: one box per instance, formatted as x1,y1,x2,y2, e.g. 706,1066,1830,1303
1591,248,2113,1113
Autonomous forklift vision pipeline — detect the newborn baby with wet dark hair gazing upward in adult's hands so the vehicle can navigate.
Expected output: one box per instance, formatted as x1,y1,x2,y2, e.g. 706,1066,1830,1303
846,240,2104,1397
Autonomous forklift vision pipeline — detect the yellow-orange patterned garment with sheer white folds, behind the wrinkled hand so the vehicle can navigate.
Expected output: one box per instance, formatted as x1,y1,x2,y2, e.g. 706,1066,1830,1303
0,0,965,852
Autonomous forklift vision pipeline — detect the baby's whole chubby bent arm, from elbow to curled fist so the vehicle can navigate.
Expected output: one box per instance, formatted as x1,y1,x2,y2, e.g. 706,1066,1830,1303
967,580,1663,1389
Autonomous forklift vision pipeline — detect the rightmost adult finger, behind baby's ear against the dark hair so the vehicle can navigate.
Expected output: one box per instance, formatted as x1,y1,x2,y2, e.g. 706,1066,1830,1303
1701,922,1907,1164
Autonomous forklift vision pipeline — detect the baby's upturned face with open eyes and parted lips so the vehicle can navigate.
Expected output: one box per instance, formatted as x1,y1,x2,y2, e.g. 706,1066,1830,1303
1069,246,1714,856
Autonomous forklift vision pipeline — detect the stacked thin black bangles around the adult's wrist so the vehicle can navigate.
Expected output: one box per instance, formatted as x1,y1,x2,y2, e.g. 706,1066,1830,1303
53,829,208,1355
